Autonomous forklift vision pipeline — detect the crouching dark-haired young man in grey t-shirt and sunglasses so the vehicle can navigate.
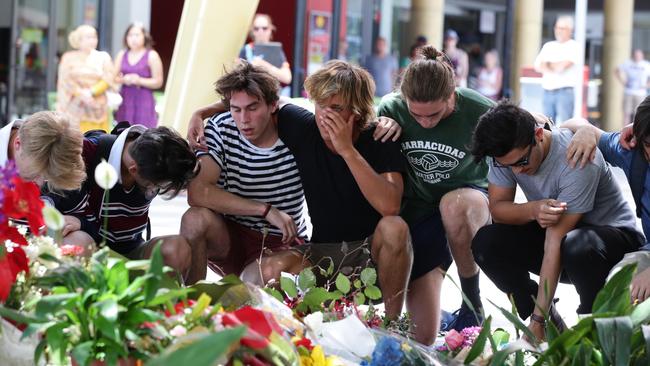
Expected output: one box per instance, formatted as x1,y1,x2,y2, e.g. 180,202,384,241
472,102,644,340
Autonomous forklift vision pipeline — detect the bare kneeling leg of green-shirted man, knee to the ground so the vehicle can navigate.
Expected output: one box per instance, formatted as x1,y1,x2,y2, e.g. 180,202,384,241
406,267,444,345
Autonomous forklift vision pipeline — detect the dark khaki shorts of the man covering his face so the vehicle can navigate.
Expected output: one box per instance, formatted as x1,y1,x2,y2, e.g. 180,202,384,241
291,237,376,286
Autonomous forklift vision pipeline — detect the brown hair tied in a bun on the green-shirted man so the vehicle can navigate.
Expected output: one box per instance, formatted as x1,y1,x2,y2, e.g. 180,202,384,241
400,45,456,103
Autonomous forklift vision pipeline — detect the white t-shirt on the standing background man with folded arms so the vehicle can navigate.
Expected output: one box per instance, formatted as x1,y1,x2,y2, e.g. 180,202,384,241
535,39,580,90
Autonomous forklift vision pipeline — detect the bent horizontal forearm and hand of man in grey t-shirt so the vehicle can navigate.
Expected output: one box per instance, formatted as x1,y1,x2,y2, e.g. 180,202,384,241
488,184,566,227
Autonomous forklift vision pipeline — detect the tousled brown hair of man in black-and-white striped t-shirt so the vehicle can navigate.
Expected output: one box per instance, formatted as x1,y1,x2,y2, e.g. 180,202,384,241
215,60,280,108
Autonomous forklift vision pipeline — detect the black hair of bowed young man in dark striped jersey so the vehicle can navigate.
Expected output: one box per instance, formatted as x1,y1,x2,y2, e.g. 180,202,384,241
129,127,198,198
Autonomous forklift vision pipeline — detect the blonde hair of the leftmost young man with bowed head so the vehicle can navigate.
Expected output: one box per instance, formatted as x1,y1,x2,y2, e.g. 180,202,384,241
18,111,86,190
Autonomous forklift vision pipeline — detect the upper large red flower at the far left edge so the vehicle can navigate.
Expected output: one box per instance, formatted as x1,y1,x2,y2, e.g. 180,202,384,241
3,177,45,234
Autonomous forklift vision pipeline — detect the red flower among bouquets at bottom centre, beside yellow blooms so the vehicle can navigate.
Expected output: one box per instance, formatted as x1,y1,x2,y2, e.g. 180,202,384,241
222,306,282,349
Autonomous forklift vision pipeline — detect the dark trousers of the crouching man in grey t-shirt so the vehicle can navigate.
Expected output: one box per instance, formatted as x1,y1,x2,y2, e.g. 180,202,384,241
472,221,643,319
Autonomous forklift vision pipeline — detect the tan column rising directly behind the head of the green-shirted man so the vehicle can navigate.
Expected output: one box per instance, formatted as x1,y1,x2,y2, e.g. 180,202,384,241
410,0,445,50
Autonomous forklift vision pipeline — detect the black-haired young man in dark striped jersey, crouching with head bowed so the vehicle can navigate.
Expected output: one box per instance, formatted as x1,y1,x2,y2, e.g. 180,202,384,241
52,125,198,276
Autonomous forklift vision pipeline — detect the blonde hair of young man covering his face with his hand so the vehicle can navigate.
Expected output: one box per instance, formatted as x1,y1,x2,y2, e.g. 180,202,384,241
305,60,375,128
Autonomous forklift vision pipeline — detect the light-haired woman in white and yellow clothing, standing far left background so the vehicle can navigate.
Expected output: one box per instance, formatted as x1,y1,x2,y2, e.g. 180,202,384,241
56,24,113,132
